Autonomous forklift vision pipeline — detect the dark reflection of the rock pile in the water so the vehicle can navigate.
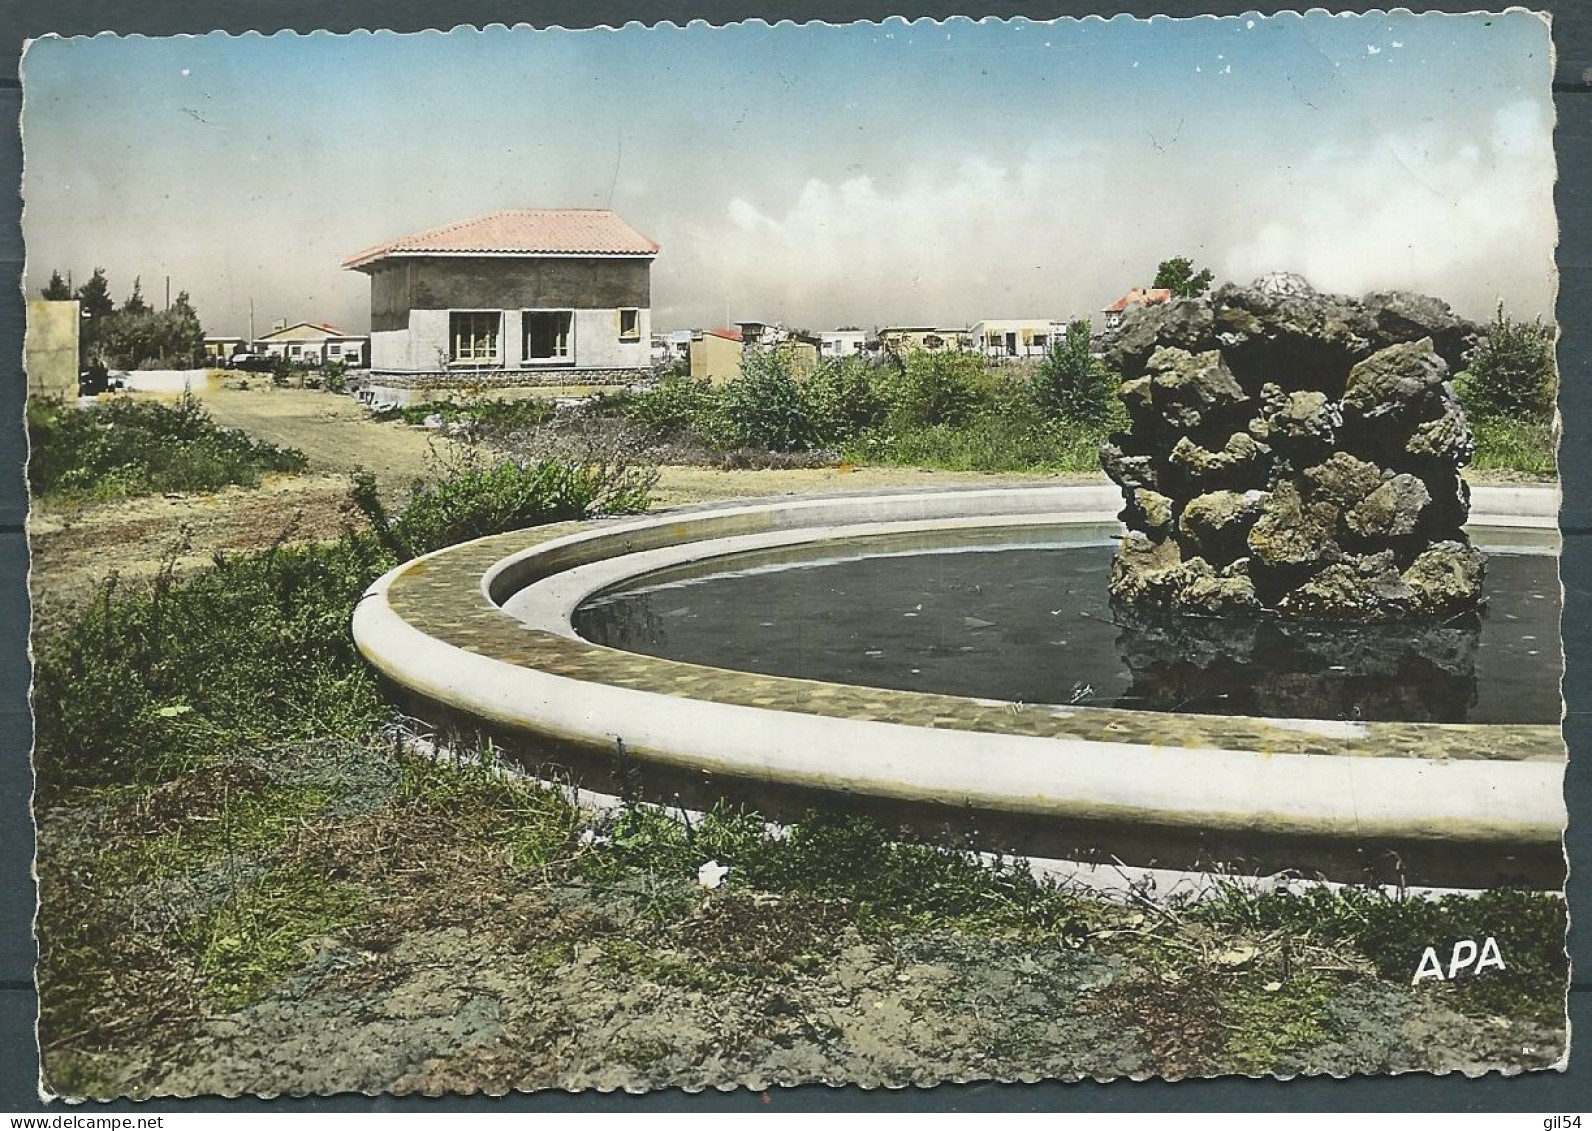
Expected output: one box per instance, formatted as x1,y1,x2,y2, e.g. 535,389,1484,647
1116,605,1481,723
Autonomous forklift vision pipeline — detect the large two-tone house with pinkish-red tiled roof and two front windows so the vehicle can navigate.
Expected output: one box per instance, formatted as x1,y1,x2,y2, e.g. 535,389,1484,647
342,209,657,400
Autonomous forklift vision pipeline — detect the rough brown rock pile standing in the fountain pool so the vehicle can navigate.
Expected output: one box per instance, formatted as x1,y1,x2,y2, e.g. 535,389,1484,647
1100,276,1484,621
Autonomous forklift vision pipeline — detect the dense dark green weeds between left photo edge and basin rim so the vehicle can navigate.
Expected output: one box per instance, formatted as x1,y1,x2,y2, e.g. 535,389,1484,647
33,535,396,792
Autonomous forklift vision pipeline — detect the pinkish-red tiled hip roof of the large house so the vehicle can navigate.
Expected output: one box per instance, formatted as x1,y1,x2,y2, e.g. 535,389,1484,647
342,209,657,269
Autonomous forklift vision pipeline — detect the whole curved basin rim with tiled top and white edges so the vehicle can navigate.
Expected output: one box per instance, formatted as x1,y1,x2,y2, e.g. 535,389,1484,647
355,486,1565,844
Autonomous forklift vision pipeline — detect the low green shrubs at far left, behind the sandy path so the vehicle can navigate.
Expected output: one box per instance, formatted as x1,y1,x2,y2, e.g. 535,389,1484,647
27,393,306,499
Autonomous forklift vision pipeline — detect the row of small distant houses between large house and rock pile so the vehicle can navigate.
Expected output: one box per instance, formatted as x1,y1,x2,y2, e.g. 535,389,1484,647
665,287,1172,381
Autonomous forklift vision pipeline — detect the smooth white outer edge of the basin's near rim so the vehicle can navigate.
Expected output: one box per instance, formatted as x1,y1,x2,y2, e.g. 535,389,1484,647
353,573,1565,844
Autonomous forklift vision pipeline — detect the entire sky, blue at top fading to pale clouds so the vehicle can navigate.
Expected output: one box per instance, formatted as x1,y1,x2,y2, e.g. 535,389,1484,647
22,13,1555,333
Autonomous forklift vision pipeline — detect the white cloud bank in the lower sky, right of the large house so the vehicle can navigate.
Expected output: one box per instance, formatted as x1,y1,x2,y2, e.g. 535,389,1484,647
654,102,1554,330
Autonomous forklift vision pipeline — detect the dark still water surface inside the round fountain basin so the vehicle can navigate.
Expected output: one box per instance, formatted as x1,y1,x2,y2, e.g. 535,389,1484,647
566,526,1560,723
